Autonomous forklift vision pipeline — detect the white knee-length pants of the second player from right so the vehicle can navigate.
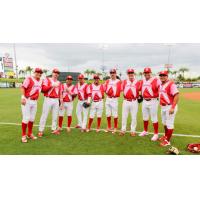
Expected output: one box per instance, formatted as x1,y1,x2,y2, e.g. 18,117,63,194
142,99,159,123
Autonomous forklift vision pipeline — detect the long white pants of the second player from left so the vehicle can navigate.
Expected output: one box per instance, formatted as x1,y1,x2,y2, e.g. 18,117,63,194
39,97,59,132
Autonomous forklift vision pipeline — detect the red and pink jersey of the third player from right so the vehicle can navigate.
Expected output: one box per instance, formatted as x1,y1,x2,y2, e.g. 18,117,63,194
122,80,140,100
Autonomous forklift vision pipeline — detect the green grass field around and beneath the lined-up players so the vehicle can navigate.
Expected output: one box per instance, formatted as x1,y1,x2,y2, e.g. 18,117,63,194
0,89,200,155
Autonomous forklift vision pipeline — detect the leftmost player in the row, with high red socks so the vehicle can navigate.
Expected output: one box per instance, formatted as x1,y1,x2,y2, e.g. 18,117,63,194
21,68,43,143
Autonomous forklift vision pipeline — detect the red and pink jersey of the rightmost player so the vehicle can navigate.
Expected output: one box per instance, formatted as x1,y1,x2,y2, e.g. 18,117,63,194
159,81,179,106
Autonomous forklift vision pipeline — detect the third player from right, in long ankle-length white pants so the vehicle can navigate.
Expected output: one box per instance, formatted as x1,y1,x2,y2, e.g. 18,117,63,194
119,69,140,137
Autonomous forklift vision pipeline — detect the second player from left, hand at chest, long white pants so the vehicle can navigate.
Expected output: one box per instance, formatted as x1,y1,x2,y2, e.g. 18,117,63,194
38,68,63,137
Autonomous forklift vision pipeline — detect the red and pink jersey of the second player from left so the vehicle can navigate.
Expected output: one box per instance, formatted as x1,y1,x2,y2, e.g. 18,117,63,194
42,78,62,98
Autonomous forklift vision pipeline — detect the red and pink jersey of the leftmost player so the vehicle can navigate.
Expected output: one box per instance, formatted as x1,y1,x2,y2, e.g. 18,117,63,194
22,77,42,100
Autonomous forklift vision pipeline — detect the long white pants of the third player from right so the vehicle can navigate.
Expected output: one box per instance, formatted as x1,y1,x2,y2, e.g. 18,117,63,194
122,99,138,132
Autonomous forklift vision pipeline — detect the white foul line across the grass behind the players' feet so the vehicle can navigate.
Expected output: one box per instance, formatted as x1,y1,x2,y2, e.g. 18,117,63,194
0,122,200,138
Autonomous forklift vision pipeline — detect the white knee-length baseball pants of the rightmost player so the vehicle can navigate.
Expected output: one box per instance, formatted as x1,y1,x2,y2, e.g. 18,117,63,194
161,105,178,129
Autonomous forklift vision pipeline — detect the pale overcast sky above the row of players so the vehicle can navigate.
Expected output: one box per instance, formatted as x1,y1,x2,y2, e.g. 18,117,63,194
0,43,200,76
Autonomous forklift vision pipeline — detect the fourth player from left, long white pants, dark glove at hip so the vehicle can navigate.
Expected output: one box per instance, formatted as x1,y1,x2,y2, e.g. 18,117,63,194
74,74,90,132
